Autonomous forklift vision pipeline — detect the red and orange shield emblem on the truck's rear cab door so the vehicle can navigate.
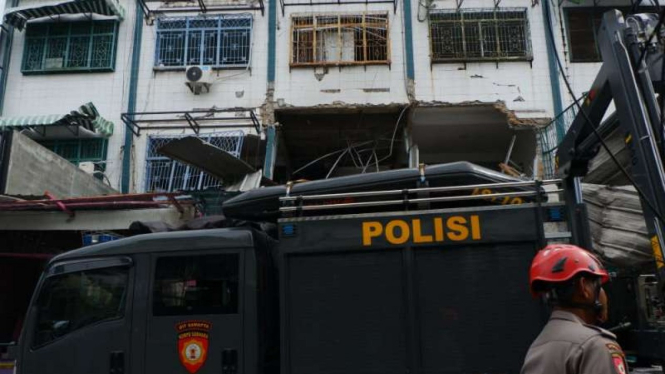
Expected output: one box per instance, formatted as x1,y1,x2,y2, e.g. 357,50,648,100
175,321,212,374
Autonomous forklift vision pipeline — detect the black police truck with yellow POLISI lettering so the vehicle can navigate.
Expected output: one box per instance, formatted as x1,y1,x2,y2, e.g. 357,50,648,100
16,163,569,374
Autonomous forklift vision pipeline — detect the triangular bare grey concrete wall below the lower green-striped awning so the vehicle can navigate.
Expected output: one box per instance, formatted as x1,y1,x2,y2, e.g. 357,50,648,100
3,132,118,198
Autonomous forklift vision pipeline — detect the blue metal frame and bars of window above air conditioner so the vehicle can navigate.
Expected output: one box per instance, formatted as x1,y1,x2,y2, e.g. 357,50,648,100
153,13,254,71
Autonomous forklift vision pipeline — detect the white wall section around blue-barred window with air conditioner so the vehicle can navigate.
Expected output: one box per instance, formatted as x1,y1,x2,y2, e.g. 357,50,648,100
130,3,268,191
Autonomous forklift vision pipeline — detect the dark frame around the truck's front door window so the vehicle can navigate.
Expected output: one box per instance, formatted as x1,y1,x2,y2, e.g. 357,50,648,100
28,257,134,351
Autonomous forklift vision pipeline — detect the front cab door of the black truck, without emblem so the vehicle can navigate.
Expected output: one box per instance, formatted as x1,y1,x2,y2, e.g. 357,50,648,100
18,257,134,374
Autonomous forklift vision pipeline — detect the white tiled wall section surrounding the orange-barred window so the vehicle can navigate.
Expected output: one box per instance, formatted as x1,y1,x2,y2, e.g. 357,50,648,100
274,2,408,107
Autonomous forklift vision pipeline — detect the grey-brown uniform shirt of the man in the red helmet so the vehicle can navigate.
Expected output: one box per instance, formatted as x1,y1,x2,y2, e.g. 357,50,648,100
521,310,628,374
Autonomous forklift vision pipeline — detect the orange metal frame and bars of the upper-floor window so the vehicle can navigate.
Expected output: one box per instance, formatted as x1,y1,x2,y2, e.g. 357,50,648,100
289,12,391,68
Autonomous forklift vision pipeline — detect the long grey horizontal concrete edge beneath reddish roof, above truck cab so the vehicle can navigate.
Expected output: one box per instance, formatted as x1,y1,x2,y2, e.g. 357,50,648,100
0,206,195,231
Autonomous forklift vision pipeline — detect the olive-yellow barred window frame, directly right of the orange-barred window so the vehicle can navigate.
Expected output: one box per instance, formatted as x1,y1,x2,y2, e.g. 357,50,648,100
428,7,533,64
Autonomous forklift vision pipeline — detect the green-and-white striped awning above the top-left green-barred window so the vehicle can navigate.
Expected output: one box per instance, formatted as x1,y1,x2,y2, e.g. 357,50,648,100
4,0,125,30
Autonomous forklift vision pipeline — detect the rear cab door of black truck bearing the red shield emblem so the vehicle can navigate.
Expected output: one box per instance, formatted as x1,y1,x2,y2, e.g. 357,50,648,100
145,250,243,374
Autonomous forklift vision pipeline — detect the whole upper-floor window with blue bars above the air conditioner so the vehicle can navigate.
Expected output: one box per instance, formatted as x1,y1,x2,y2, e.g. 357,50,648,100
155,14,252,68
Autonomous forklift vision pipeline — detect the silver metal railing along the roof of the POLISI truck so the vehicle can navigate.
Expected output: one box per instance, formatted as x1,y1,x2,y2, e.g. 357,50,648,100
279,179,563,213
